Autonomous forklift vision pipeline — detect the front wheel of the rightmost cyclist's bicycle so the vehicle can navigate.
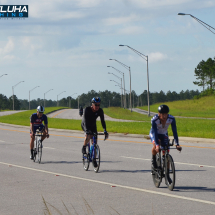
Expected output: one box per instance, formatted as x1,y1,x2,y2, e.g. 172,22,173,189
165,154,175,191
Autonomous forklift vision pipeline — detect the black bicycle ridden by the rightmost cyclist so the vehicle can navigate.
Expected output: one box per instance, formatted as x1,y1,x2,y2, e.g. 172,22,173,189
151,140,180,191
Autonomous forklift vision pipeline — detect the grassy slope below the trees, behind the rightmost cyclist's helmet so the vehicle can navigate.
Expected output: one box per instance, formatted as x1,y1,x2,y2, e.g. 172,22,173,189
138,95,215,118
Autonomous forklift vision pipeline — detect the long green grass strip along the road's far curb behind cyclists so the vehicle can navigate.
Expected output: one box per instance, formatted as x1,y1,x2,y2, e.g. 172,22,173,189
0,107,215,138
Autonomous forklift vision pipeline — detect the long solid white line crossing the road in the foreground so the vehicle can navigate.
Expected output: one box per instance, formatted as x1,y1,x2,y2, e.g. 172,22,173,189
0,162,215,205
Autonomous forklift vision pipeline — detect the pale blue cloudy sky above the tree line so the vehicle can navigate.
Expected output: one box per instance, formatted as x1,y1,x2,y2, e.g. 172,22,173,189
0,0,215,100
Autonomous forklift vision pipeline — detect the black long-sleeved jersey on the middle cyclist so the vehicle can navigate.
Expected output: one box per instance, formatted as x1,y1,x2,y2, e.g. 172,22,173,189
81,106,106,132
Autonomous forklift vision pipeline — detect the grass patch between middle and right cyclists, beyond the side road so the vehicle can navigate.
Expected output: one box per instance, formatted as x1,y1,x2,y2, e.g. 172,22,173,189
103,107,151,122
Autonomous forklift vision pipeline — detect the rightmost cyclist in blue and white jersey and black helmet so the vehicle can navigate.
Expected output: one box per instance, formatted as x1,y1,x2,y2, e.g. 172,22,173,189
149,105,182,168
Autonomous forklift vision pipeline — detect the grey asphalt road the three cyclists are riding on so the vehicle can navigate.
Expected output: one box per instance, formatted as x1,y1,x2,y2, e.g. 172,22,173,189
0,125,215,215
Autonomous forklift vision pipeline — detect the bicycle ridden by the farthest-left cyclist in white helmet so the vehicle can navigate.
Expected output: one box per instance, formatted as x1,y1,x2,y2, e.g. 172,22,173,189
33,129,44,163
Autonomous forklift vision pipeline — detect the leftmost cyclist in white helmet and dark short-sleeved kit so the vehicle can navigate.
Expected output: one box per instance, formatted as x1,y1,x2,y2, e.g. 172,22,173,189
30,106,49,160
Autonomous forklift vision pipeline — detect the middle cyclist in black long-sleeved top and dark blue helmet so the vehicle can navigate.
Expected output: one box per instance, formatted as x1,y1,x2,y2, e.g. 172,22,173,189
81,97,108,167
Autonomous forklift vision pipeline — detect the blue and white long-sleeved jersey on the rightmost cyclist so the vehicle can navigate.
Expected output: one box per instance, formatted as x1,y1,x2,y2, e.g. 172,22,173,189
149,114,179,145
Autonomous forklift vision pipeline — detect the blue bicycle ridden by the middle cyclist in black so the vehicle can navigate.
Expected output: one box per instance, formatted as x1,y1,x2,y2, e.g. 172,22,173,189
83,133,106,173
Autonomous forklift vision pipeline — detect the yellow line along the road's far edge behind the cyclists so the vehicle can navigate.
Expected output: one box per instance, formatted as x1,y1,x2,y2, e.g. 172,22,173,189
0,128,215,149
